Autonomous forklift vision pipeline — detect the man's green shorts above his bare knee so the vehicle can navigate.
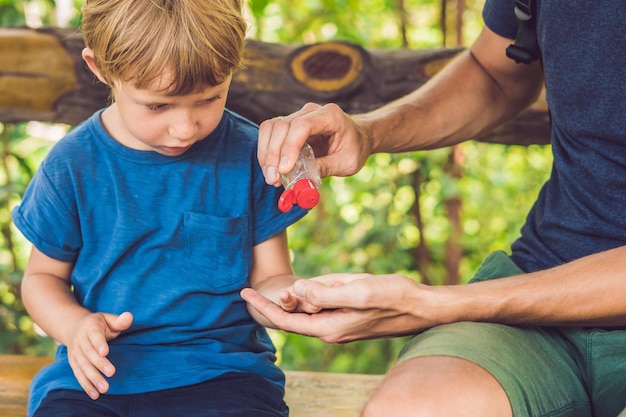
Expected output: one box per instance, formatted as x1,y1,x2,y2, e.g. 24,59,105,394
398,252,626,417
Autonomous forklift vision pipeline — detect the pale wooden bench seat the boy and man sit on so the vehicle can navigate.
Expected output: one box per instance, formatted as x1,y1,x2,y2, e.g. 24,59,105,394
0,355,382,417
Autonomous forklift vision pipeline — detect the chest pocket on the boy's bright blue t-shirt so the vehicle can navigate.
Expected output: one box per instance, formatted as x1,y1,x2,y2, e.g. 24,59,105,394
184,212,251,293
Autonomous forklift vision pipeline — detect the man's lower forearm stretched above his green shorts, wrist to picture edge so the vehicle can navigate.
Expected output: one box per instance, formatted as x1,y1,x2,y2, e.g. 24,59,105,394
449,247,626,327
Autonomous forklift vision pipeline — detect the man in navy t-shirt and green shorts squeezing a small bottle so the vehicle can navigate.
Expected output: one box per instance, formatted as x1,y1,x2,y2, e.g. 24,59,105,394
242,0,626,417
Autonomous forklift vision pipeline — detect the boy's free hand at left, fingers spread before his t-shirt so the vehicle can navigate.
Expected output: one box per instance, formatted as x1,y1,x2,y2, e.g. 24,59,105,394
67,312,133,400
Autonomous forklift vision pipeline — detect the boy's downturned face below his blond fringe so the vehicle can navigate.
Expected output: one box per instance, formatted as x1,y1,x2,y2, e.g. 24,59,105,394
102,73,231,156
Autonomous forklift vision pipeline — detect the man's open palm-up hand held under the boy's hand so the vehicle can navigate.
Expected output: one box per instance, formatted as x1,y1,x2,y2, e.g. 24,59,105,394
241,274,438,343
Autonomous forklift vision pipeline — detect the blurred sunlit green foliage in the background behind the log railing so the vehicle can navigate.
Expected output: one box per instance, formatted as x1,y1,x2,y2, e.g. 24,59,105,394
0,0,551,373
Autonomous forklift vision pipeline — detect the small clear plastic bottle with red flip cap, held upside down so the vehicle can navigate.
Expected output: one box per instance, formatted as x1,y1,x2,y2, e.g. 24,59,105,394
278,143,322,212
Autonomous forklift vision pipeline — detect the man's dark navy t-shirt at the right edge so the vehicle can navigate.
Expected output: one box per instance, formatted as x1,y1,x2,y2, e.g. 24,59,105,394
483,0,626,271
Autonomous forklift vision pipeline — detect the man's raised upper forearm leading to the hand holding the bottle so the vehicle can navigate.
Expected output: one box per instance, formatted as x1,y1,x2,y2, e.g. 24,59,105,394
355,30,542,153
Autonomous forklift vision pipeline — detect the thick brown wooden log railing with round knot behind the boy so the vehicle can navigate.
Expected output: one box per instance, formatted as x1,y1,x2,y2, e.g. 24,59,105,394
0,28,550,145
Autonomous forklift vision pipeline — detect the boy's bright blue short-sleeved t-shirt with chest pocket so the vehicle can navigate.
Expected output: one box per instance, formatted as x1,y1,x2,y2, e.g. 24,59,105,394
13,110,306,414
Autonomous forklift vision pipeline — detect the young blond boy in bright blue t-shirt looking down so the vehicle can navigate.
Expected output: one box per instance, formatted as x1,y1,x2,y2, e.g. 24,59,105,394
13,0,305,417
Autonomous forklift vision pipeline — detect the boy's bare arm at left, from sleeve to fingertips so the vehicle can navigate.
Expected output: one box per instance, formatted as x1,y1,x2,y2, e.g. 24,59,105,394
22,247,132,399
